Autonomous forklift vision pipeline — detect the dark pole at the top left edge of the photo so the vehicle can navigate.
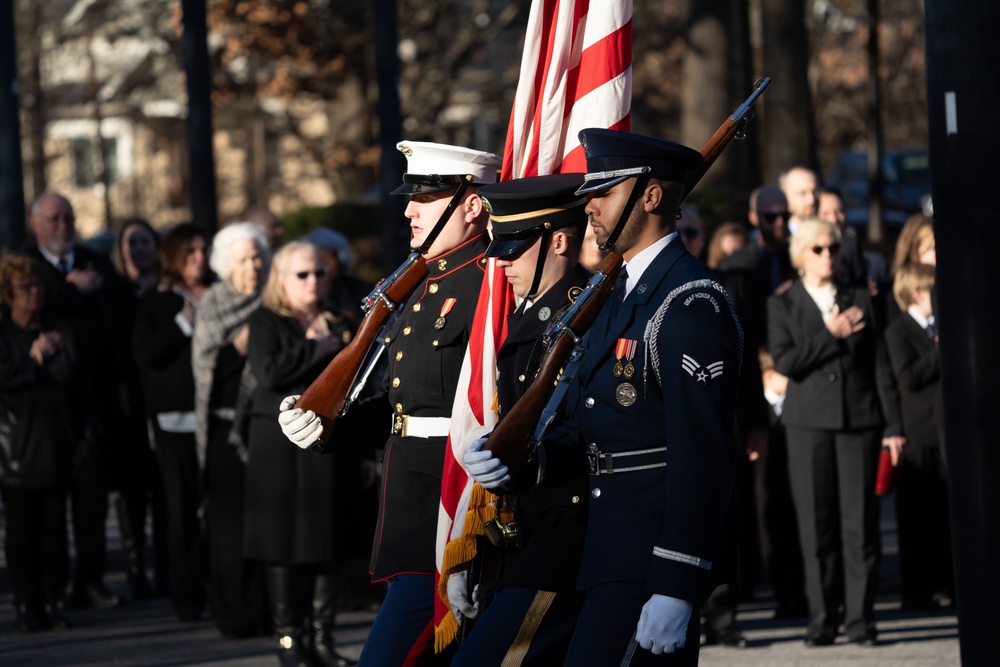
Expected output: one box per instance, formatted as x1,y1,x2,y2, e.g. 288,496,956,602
0,0,25,248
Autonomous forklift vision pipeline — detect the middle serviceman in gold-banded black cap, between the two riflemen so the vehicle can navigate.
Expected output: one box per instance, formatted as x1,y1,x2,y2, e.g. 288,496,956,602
448,174,589,667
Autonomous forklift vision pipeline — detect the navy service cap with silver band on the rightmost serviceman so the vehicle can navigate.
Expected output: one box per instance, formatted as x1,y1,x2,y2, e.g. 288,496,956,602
577,128,702,194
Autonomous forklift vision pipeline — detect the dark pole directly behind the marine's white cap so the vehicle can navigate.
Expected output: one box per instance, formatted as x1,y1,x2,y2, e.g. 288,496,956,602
372,0,410,271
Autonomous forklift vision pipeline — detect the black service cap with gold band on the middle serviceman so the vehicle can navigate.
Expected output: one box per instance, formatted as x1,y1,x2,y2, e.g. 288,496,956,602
476,173,587,257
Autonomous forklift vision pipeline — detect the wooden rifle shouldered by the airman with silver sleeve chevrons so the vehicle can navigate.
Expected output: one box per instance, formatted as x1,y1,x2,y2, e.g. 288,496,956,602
484,77,771,489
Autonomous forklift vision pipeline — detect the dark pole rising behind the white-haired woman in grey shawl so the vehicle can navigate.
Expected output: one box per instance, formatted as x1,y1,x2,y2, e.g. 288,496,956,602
181,0,219,233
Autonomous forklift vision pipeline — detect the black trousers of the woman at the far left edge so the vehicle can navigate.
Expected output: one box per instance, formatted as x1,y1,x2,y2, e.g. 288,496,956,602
0,484,69,612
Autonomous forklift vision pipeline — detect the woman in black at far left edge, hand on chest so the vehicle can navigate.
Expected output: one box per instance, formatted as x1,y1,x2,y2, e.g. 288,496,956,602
0,255,96,632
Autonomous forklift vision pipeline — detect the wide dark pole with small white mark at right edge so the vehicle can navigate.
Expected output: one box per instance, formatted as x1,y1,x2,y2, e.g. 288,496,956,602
926,0,1000,667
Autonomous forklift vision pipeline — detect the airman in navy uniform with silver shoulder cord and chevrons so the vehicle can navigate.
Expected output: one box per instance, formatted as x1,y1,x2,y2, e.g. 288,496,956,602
468,129,742,665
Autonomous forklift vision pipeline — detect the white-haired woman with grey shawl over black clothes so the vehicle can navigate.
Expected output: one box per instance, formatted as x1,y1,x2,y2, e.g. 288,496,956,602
191,222,270,638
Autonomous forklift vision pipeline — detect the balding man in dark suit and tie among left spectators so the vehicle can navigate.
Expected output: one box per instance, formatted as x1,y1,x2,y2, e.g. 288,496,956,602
27,192,130,608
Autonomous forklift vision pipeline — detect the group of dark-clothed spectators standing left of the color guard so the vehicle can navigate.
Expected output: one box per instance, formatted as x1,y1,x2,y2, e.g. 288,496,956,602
0,193,378,664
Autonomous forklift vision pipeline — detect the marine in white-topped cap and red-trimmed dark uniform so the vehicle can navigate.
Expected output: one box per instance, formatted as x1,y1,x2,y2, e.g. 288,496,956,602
360,141,500,666
